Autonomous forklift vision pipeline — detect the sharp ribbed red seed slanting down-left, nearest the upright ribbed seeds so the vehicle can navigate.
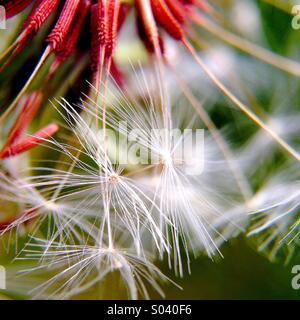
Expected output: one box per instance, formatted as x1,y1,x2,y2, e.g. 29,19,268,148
47,0,80,52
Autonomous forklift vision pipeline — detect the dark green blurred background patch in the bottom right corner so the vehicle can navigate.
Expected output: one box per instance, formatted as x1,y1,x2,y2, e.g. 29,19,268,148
165,237,300,299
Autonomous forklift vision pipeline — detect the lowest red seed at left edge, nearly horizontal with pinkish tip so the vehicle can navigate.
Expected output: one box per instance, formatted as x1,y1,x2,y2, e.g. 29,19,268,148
0,124,58,160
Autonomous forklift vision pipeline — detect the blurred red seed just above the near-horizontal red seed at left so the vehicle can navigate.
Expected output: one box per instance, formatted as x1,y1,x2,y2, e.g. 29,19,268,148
5,91,43,148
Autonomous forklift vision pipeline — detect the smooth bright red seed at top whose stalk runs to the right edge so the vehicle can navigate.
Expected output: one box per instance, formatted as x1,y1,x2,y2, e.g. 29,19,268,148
151,0,184,40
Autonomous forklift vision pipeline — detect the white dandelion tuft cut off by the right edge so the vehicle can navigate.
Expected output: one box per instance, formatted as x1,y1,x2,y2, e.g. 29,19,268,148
249,169,300,258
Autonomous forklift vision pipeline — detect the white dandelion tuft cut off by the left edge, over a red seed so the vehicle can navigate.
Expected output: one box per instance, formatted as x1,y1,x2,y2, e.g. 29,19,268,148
0,174,94,244
